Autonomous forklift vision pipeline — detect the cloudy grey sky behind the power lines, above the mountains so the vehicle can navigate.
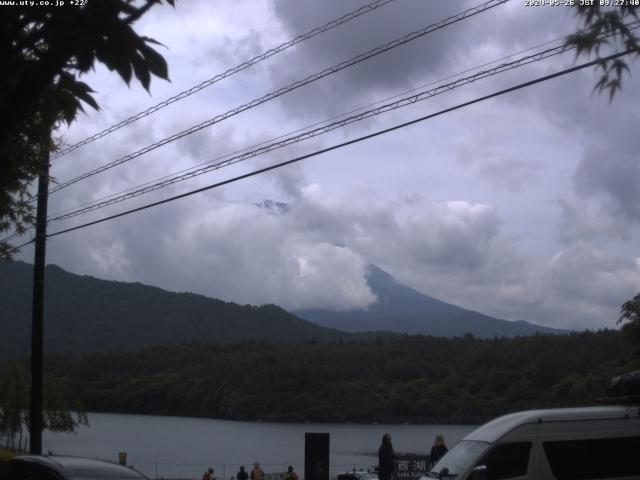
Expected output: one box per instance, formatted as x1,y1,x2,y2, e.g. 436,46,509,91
13,0,640,330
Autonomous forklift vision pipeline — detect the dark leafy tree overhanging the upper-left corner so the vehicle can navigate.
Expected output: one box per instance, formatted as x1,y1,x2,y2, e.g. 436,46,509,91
0,0,174,258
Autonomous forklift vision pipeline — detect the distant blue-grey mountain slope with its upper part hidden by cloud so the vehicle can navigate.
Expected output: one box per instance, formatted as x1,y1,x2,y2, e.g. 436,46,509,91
293,265,562,338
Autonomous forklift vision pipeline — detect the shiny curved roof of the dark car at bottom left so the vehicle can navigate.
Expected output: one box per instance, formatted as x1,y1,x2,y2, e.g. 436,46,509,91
12,455,147,479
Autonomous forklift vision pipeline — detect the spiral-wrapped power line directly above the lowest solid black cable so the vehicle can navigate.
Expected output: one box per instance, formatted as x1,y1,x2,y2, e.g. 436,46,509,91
49,45,566,223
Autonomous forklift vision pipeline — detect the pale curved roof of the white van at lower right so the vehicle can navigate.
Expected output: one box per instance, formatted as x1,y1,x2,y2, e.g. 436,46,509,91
463,406,640,443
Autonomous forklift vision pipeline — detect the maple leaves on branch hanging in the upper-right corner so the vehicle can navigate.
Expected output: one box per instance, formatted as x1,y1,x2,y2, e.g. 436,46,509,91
565,1,640,100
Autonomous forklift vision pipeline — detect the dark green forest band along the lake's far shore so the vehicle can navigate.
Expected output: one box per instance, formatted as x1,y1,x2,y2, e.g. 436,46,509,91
4,331,640,423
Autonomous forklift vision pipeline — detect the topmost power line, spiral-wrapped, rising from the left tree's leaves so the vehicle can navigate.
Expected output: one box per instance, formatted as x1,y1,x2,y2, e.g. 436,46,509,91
52,0,394,159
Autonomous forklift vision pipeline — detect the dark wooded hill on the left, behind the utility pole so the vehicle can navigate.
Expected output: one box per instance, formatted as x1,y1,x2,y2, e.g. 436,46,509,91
0,262,352,356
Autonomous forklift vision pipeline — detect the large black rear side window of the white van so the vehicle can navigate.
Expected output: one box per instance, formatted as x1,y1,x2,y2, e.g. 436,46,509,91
542,437,640,480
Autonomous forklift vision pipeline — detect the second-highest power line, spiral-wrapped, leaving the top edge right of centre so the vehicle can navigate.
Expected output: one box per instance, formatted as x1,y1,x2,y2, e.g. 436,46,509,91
49,0,509,194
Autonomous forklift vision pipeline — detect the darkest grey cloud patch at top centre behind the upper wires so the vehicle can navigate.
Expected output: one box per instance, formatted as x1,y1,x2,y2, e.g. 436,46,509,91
272,0,472,115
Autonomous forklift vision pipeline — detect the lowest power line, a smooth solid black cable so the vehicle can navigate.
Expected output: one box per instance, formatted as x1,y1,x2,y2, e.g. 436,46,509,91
20,49,634,251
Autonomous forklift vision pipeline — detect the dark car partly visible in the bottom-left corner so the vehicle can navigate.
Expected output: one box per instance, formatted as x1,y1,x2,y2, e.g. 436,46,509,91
5,455,148,480
